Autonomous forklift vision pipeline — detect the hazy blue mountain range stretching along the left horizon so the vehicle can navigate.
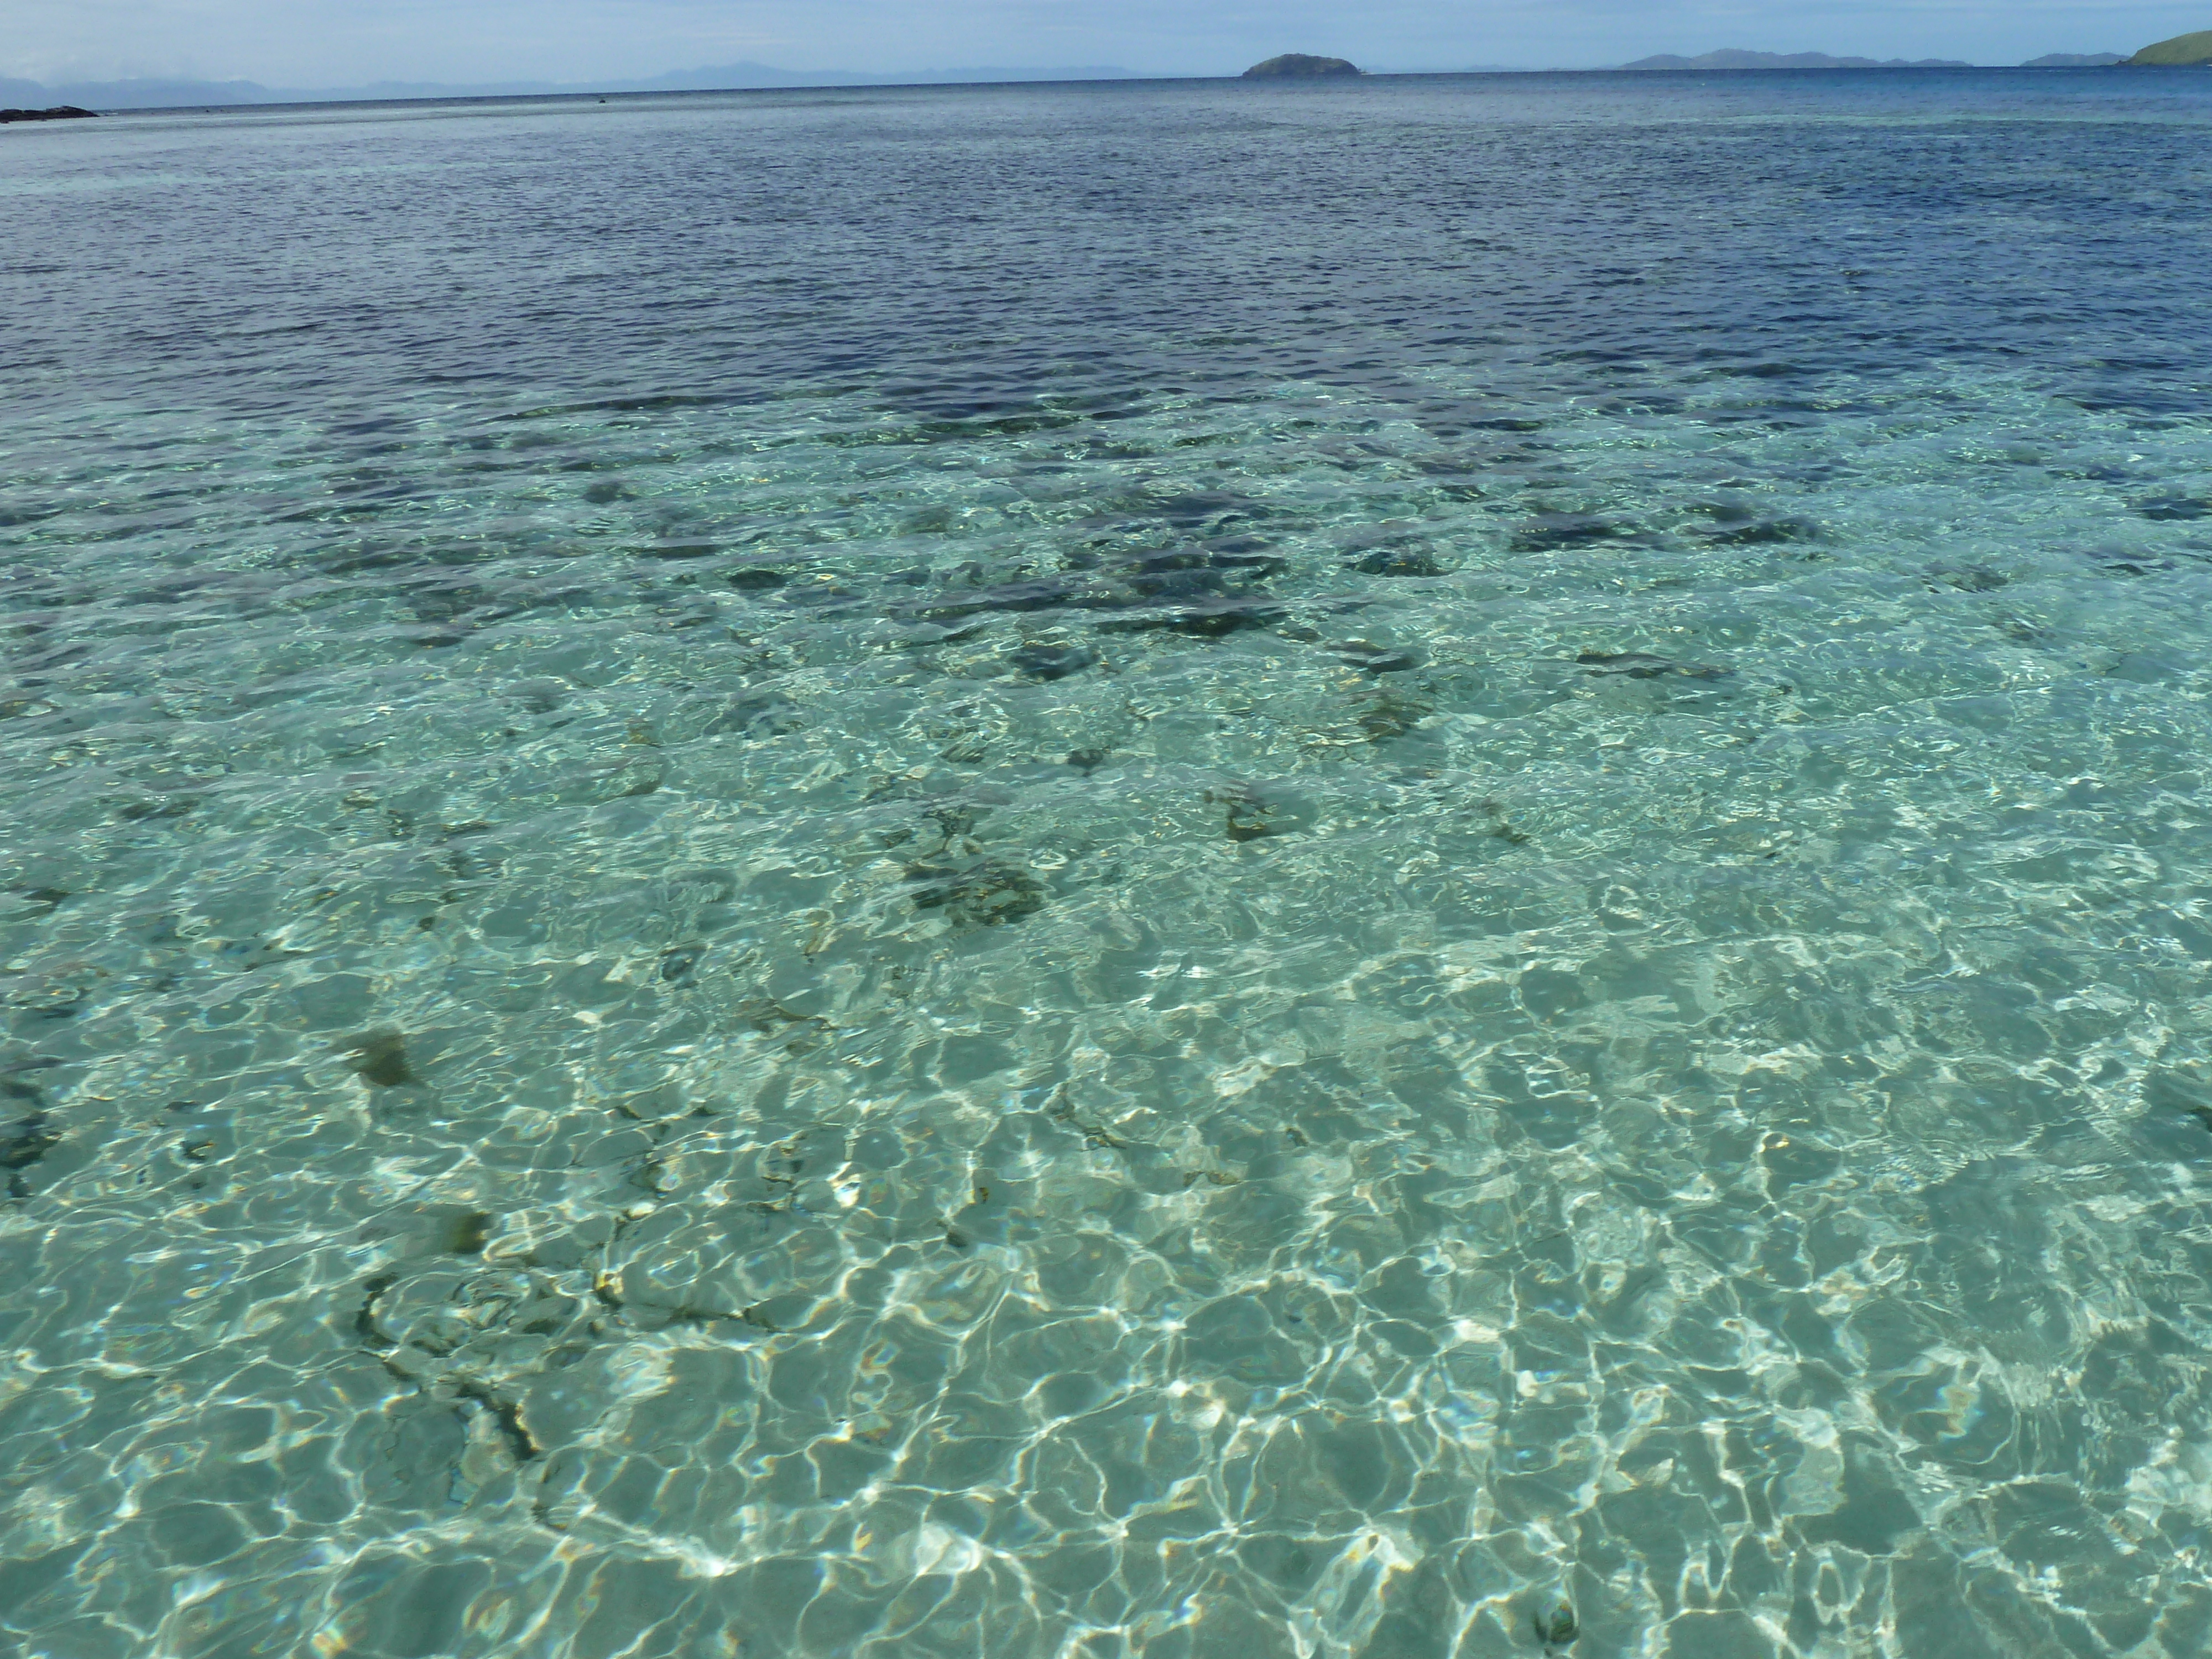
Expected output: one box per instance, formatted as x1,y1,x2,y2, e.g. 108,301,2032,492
0,64,1144,108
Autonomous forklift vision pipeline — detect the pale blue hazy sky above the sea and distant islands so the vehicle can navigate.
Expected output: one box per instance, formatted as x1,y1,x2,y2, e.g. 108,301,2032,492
13,0,2212,86
